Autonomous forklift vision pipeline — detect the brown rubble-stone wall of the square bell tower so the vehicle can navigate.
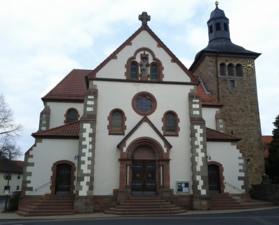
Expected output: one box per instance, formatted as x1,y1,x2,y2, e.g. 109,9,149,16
192,54,264,185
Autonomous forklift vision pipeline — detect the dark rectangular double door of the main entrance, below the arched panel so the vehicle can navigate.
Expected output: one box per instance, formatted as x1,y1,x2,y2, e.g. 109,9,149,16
131,160,157,195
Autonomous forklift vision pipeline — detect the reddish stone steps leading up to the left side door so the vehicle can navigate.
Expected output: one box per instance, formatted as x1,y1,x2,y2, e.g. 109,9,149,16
16,195,75,216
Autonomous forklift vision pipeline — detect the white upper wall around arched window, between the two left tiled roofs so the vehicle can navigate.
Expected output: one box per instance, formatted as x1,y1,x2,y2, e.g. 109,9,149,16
47,102,83,128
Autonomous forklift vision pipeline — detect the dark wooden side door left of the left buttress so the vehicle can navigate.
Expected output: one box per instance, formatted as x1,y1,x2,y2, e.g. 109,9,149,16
55,164,71,195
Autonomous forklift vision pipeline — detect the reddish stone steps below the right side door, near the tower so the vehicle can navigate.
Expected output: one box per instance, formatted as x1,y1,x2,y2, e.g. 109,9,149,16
210,193,275,210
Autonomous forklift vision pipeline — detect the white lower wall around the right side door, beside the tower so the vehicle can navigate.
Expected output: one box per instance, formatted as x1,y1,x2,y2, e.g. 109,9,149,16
207,142,244,194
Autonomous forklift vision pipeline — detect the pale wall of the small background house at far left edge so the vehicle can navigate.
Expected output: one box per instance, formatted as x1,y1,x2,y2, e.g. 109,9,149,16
0,172,22,196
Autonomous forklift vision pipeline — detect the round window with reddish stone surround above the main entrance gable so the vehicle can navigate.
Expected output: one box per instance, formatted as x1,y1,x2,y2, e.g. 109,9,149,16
132,92,157,116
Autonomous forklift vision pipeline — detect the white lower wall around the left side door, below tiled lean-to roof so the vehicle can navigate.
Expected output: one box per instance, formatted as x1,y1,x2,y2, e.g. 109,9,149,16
27,139,78,195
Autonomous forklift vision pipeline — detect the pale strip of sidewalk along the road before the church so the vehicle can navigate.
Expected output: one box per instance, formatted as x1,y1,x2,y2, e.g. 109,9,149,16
0,204,279,221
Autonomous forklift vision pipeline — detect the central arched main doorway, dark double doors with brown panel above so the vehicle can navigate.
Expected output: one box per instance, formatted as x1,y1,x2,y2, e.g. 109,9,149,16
131,145,157,195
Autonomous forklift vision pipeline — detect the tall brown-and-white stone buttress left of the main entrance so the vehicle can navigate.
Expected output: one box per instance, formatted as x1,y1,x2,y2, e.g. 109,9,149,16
74,82,98,213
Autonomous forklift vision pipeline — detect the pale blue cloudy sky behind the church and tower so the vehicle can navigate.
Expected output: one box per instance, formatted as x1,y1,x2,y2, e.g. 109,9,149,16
0,0,279,159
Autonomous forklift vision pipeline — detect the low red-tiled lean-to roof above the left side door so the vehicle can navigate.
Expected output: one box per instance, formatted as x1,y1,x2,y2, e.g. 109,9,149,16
32,121,80,139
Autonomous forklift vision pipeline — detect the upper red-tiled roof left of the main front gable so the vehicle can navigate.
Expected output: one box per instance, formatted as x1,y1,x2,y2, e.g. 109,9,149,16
42,69,92,101
